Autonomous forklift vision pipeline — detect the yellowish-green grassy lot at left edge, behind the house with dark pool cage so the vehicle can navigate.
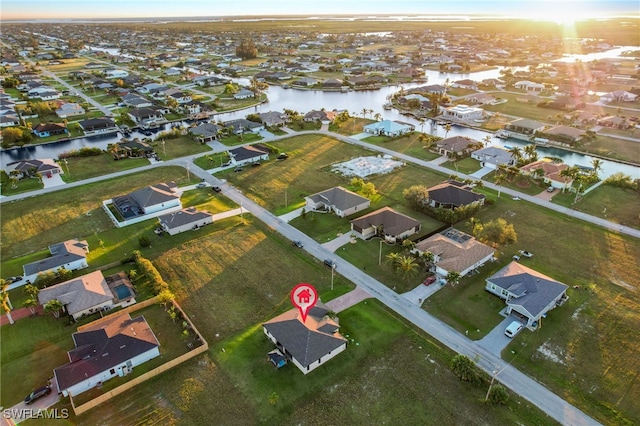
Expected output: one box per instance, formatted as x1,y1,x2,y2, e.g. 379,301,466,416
1,167,197,260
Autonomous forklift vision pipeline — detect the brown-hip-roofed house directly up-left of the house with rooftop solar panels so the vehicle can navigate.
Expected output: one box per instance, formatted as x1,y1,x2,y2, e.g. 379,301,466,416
351,207,422,241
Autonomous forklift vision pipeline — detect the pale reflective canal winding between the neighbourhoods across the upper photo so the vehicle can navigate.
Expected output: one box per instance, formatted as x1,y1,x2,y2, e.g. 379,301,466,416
0,47,640,178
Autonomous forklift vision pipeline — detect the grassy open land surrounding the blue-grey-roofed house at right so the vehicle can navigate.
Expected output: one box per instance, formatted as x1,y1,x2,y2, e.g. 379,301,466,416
425,197,640,424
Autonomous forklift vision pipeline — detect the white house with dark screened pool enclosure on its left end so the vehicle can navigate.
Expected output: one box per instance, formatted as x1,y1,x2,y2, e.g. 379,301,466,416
113,182,182,219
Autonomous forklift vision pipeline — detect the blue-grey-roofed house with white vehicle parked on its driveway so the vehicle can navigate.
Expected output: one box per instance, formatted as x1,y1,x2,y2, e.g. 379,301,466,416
485,261,568,326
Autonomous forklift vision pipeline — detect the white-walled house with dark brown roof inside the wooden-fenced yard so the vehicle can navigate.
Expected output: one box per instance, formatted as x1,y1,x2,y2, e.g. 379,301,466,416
53,313,160,396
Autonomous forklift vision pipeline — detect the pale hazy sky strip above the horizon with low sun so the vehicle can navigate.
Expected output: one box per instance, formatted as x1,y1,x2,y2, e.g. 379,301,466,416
0,0,640,20
